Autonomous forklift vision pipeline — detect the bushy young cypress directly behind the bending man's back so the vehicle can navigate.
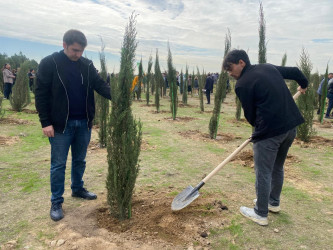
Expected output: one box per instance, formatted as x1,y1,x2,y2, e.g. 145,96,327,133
297,48,315,142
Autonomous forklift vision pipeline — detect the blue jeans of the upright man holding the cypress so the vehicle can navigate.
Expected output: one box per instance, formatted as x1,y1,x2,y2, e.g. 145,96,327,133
49,119,91,203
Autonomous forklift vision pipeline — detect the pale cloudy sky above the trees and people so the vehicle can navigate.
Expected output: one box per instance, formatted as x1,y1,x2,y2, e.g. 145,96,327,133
0,0,333,74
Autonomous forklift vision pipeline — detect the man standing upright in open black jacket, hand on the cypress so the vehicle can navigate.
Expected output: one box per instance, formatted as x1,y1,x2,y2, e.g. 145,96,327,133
35,30,111,221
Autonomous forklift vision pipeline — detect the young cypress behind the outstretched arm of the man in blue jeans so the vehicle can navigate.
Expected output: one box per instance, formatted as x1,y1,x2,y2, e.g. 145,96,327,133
97,40,109,148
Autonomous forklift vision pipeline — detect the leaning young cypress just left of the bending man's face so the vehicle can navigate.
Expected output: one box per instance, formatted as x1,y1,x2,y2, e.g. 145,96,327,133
209,30,231,139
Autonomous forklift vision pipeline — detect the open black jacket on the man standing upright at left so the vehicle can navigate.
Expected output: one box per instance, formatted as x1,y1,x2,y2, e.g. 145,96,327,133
35,51,111,133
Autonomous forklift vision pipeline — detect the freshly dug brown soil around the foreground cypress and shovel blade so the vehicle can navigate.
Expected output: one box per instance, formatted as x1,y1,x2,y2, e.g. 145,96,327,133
97,192,228,246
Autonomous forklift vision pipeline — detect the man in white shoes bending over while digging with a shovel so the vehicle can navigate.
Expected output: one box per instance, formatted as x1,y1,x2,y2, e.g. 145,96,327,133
223,50,308,225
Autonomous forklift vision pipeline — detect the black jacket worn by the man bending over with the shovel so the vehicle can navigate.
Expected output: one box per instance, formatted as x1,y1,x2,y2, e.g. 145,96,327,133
235,64,308,142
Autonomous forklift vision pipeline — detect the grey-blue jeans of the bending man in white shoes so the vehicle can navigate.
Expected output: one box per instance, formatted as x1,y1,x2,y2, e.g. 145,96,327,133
253,128,296,217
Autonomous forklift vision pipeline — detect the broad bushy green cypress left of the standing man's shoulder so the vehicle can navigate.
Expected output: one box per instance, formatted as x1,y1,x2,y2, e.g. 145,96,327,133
10,61,31,112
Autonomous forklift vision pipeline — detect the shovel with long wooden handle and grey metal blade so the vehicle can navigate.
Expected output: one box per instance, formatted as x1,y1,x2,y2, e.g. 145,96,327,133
171,91,301,211
